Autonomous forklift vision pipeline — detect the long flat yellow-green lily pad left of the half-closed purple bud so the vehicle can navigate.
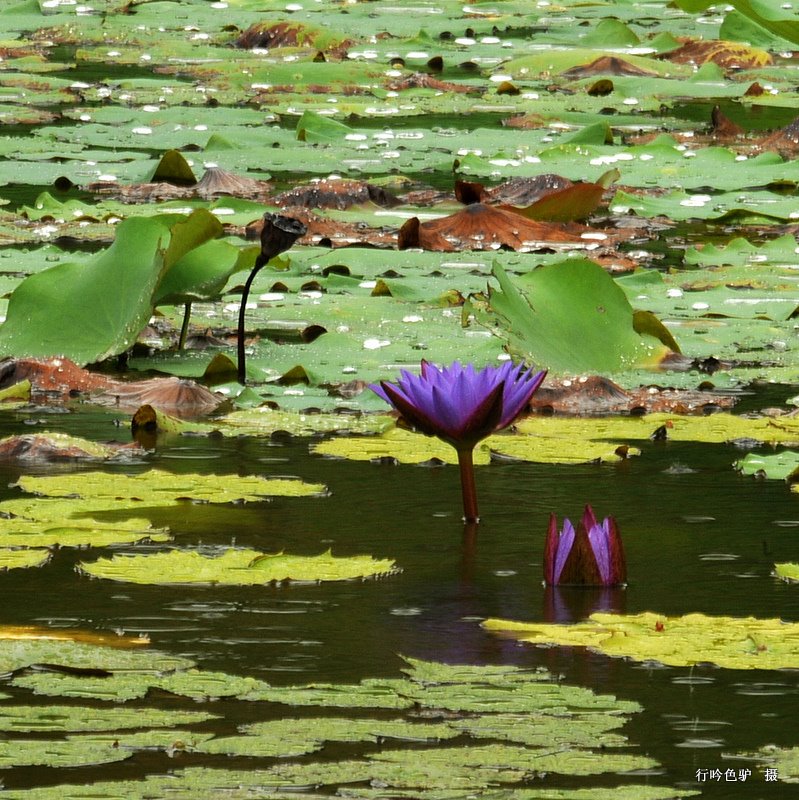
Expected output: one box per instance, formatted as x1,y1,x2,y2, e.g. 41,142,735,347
79,549,397,586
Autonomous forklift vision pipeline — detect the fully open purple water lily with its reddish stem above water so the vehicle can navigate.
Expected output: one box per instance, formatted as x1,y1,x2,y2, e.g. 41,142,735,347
369,361,546,522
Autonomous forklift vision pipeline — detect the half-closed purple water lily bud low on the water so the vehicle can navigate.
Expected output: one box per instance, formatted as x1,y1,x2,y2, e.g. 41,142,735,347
544,505,627,586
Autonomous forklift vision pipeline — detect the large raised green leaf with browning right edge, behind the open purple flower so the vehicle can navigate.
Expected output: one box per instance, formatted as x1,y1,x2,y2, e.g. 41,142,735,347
475,259,670,374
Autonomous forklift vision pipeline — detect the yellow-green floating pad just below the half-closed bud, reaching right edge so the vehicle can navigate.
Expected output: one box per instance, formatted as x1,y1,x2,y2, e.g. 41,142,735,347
483,612,799,669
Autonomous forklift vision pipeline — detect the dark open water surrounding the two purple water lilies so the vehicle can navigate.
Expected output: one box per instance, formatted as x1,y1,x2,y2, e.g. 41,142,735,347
0,404,799,798
